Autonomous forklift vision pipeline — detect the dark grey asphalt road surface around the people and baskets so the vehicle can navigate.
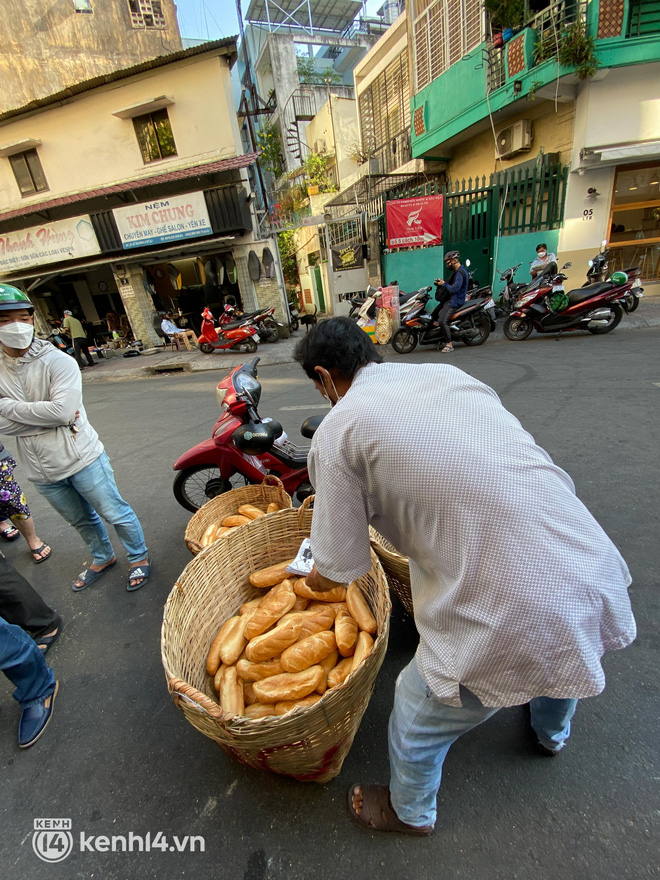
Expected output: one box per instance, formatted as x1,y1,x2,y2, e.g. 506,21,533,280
0,330,660,880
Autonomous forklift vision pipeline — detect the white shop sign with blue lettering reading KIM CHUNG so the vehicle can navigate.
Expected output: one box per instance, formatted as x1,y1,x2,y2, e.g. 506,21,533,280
112,192,213,250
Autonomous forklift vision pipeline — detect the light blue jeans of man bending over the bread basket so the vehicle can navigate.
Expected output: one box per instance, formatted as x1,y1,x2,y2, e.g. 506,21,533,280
389,658,577,827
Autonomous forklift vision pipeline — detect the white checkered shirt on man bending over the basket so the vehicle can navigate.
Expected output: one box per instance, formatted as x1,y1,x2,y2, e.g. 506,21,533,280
309,364,635,706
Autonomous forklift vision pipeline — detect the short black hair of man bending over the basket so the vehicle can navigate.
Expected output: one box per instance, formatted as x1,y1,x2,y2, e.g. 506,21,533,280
293,317,383,379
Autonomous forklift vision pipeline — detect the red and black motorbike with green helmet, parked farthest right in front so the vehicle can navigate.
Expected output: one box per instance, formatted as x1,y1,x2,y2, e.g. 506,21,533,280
503,263,633,342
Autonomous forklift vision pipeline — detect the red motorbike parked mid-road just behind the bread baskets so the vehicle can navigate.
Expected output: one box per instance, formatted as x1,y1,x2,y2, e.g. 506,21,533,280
172,358,323,512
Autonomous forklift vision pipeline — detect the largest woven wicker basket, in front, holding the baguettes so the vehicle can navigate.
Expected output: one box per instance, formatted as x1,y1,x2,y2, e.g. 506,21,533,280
161,501,391,782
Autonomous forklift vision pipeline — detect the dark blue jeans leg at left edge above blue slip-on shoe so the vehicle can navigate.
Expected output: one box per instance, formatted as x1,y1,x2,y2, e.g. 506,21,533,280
0,617,55,709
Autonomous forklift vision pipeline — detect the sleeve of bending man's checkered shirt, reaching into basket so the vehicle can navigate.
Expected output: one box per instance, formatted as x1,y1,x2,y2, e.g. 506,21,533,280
308,450,371,583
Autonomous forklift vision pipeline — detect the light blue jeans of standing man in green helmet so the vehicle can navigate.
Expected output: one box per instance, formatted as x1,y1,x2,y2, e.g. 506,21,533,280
34,452,147,565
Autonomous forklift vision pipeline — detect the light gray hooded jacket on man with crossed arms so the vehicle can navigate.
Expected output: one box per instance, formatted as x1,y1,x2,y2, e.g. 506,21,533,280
0,336,103,483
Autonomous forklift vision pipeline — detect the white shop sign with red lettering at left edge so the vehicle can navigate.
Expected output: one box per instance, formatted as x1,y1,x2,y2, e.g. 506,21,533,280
0,214,101,272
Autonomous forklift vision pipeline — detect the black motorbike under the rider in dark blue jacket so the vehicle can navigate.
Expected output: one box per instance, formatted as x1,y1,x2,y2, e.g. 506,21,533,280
392,283,491,354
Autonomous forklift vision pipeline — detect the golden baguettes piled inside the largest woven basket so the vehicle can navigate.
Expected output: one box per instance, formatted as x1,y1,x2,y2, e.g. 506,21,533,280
206,559,378,719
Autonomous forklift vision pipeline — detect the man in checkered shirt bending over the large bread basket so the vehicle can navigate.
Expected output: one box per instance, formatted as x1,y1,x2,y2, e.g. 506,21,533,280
295,318,635,835
